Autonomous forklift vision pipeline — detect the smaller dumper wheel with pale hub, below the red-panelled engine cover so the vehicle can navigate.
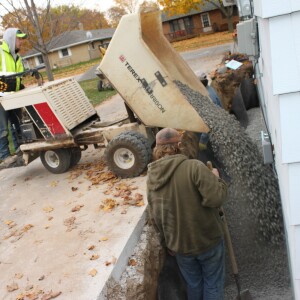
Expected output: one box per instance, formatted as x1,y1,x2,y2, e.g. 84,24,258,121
40,149,71,174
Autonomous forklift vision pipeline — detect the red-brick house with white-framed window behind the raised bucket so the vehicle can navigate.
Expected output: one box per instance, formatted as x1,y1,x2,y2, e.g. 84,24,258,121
161,2,239,42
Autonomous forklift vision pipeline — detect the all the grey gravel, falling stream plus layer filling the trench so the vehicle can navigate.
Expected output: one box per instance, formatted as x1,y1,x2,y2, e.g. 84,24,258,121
176,82,293,300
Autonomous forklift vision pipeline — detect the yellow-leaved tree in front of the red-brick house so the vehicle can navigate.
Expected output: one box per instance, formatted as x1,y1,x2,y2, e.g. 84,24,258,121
158,0,233,32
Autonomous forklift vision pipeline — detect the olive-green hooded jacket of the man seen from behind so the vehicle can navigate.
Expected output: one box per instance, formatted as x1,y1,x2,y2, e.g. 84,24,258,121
147,154,227,255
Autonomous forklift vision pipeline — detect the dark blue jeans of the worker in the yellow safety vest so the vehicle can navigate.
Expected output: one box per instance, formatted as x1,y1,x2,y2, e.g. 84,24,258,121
0,104,19,160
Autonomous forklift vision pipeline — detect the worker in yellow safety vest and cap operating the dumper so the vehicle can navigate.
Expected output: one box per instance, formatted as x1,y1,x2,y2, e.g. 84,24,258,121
0,28,27,166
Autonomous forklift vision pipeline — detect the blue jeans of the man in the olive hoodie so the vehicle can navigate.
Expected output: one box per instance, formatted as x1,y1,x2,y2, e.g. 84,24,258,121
176,240,225,300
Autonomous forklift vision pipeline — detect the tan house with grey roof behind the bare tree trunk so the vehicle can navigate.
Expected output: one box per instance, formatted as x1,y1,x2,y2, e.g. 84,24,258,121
22,28,115,69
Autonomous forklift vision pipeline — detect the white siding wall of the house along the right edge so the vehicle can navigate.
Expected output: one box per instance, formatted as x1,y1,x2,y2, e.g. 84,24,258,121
254,0,300,300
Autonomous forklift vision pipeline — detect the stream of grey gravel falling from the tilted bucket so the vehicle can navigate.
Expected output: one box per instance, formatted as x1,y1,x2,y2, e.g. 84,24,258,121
176,82,283,244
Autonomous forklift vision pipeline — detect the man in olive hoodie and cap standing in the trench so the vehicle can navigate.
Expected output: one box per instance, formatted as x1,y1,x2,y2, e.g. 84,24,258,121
147,128,227,300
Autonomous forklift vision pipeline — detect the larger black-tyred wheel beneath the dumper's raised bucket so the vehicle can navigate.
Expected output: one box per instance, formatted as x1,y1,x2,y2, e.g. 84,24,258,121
104,133,149,178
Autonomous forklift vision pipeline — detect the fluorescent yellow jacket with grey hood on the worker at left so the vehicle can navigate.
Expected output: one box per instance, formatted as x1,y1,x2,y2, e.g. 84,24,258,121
0,28,24,92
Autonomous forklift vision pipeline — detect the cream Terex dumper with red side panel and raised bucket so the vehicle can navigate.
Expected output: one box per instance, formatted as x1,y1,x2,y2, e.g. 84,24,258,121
0,10,208,177
